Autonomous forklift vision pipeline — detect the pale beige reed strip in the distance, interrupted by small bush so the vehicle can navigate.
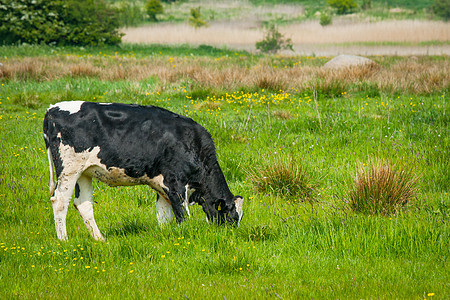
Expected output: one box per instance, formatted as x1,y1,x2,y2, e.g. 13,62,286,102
123,19,450,49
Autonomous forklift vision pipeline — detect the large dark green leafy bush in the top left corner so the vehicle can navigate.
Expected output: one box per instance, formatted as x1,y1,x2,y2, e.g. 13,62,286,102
0,0,122,45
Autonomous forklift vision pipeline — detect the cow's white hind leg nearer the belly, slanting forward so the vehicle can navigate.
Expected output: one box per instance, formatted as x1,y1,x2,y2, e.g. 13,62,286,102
73,175,104,240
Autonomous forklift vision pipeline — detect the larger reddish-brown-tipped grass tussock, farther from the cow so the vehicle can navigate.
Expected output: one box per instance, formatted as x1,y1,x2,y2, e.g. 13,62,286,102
347,160,419,215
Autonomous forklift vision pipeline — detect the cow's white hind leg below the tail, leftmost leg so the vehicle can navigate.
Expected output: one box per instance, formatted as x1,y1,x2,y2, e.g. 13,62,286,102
50,174,78,240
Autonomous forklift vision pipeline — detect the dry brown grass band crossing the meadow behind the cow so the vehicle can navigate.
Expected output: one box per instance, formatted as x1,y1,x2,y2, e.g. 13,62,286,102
0,56,450,96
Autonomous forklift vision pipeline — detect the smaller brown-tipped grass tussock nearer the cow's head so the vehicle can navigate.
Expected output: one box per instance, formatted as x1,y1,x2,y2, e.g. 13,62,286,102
248,155,318,201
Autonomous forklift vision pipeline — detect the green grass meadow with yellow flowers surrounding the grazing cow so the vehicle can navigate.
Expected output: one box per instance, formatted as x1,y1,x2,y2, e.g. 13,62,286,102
0,45,450,299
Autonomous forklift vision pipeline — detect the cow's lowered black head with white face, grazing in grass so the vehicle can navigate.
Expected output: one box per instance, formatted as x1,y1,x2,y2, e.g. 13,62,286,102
203,196,244,226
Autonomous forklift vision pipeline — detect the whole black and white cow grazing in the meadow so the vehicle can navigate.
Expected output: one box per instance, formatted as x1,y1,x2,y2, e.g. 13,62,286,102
44,101,243,240
